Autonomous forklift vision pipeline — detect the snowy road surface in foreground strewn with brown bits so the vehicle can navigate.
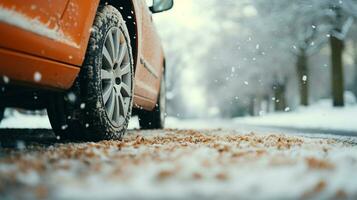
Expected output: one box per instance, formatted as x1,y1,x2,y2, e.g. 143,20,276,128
0,129,357,199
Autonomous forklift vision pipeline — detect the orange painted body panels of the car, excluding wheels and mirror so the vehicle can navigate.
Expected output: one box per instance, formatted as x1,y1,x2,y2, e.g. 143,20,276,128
0,0,165,110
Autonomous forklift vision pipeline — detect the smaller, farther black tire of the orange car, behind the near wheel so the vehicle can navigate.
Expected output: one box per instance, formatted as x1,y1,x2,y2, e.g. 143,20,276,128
138,75,166,129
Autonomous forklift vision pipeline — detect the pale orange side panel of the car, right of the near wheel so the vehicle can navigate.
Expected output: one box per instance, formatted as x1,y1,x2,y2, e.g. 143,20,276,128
135,0,163,108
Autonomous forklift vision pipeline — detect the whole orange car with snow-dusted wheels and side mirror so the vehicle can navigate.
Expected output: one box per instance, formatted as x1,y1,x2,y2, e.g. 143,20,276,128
0,0,173,140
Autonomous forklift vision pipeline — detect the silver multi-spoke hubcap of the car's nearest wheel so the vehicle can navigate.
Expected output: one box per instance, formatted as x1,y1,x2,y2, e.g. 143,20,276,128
101,27,132,126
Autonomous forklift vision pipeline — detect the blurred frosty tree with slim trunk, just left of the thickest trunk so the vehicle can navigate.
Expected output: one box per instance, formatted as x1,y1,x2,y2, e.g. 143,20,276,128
255,0,326,106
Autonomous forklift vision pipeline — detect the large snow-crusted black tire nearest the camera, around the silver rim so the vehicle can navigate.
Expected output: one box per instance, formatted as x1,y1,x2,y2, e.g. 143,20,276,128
48,5,134,141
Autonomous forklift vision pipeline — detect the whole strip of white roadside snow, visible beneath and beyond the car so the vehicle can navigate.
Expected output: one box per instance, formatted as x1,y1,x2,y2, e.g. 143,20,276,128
0,97,357,135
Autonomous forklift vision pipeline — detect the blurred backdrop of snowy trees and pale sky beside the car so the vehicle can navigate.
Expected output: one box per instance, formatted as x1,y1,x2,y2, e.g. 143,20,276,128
154,0,357,118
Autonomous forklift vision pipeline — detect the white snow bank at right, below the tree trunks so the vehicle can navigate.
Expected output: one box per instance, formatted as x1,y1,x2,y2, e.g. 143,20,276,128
234,100,357,135
